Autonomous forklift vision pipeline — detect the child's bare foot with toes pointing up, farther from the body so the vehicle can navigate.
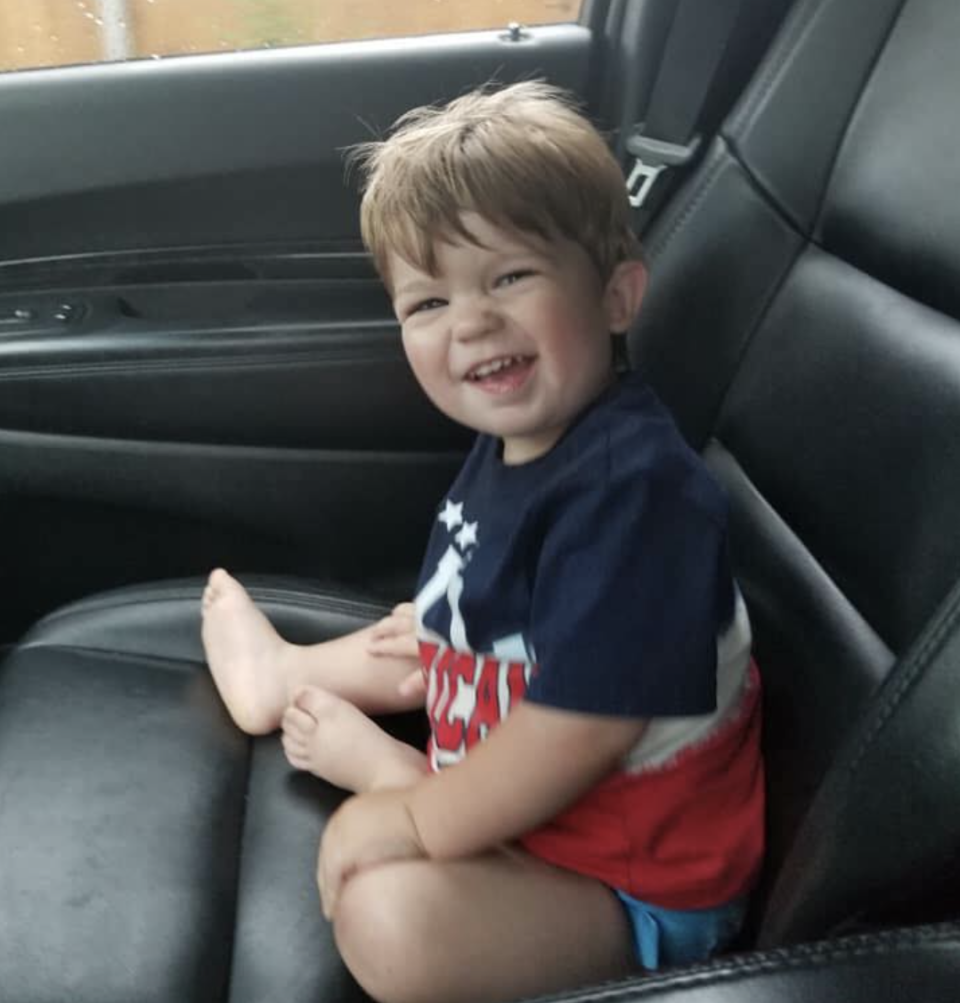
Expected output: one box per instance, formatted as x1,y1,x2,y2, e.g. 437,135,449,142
202,568,288,735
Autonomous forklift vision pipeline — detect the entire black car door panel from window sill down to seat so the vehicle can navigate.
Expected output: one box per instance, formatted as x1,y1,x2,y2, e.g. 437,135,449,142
0,25,592,639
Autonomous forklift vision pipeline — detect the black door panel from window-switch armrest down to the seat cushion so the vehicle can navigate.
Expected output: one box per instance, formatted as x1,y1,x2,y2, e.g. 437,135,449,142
0,255,468,637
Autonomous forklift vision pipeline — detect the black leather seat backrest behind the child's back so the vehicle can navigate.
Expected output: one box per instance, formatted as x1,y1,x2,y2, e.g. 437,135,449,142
631,0,960,945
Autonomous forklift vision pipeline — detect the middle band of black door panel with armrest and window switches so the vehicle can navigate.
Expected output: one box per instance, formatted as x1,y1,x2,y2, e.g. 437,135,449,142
0,255,465,448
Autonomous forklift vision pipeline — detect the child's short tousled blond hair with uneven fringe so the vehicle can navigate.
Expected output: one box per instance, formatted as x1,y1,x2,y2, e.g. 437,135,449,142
349,81,639,286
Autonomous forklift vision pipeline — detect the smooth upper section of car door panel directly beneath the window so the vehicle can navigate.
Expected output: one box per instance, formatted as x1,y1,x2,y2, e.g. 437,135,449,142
0,25,591,261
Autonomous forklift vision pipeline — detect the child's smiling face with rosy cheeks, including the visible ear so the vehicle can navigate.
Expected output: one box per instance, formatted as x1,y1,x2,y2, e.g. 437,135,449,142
389,214,644,463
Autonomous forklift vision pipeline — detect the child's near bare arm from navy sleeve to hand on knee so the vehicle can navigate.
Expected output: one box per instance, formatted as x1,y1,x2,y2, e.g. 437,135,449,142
319,703,645,917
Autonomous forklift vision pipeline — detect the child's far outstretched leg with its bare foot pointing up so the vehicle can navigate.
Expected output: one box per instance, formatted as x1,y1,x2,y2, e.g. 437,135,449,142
203,569,422,735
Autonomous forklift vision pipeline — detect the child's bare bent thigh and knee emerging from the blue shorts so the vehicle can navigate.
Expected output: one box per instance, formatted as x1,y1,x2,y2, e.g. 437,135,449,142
334,850,639,1003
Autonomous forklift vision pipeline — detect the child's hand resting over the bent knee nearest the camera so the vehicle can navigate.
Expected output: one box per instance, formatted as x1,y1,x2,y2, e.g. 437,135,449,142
317,790,428,920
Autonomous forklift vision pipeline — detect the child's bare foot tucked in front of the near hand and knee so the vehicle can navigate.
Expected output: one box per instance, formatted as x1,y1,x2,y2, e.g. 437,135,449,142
282,686,426,793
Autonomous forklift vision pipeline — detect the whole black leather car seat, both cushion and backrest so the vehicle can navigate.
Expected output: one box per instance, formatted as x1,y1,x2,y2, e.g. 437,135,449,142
0,0,960,1003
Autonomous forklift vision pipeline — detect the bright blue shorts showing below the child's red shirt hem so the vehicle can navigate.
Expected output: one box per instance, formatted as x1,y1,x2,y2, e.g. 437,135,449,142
614,889,746,969
